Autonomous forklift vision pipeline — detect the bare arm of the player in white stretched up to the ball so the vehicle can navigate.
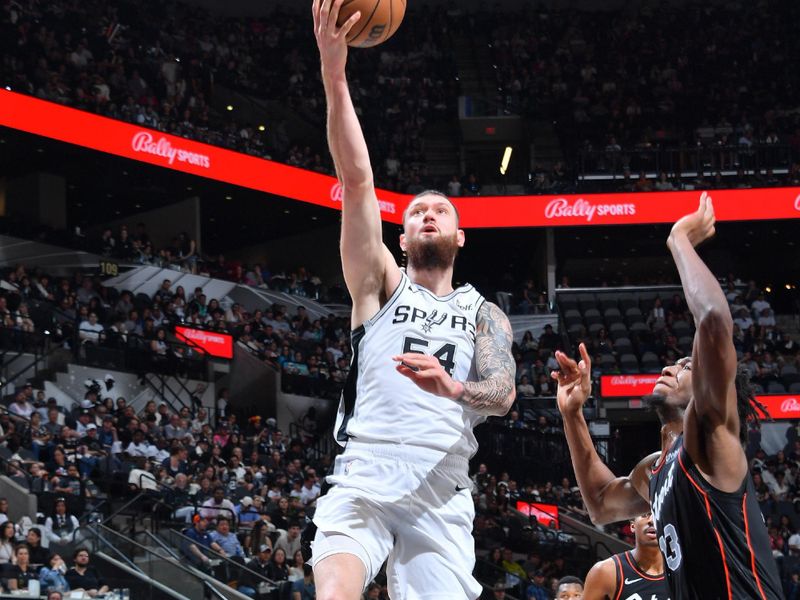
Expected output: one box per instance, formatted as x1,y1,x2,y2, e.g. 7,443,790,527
312,0,401,327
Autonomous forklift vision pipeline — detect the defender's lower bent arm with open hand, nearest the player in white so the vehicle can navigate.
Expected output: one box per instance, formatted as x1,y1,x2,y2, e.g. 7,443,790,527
552,344,658,525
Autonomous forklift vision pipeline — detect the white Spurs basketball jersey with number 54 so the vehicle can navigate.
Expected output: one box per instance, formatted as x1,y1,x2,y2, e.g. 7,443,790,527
335,273,485,458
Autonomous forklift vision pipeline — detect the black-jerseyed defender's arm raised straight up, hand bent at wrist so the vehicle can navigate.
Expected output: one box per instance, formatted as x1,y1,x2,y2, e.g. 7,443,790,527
667,192,747,491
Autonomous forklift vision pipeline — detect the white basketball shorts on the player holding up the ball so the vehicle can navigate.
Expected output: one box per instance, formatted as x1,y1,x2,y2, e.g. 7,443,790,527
310,441,482,600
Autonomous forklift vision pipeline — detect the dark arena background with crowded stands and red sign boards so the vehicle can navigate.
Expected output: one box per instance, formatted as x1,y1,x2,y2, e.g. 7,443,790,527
0,0,800,600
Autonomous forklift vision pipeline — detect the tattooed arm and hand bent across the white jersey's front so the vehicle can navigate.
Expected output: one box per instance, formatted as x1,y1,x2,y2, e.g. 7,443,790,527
393,302,517,417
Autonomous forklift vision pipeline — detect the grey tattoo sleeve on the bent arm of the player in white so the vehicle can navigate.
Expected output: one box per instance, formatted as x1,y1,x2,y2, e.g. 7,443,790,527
458,302,517,416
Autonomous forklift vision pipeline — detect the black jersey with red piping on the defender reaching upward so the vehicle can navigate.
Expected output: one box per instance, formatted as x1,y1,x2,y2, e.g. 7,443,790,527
650,436,783,600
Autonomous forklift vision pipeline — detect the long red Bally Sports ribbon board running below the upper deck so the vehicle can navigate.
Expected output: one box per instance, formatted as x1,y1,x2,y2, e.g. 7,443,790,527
0,90,800,228
